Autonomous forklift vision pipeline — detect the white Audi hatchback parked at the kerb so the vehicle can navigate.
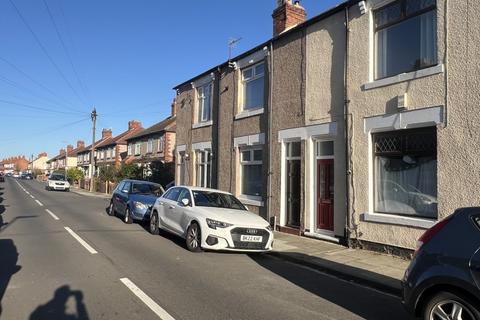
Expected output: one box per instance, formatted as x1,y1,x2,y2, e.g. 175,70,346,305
150,186,273,252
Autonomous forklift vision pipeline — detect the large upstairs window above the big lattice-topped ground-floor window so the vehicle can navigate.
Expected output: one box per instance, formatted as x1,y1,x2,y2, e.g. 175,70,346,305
374,0,437,79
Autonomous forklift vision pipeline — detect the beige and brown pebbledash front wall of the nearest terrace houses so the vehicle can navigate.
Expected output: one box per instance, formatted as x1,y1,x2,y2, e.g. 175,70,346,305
176,0,480,250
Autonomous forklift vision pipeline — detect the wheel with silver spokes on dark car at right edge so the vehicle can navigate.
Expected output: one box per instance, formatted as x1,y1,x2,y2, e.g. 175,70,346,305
423,292,480,320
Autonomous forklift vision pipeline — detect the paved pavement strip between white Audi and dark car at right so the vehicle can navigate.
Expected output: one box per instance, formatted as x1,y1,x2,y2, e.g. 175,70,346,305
271,232,410,296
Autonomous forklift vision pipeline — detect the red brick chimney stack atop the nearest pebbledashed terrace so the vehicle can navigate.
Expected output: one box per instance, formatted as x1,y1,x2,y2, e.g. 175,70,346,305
272,0,307,37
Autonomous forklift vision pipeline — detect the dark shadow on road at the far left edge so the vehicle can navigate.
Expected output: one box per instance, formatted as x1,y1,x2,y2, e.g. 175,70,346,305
0,239,21,318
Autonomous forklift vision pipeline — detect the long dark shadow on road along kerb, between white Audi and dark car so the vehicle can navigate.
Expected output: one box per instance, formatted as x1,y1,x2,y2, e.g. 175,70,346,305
249,254,410,320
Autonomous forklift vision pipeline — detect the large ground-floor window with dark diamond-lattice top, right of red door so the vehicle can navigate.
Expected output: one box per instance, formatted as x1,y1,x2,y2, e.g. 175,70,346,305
373,127,438,218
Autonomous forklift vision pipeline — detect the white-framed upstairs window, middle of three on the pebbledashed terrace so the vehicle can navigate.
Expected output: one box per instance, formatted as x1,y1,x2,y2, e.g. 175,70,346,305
242,63,265,110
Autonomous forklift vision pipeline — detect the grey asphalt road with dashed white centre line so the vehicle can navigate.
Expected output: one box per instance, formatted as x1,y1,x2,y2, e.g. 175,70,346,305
0,178,408,320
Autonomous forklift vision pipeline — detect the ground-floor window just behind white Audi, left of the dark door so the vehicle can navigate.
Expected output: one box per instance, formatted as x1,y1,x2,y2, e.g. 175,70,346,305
240,148,263,196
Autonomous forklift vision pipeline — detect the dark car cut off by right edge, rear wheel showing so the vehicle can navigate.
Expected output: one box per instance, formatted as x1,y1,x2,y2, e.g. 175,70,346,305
403,208,480,320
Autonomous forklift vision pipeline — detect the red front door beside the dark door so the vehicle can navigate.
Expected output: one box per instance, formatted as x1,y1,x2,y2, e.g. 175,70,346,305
317,159,334,231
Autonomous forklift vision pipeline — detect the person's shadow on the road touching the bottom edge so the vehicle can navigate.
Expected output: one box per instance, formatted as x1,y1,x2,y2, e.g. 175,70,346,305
29,285,89,320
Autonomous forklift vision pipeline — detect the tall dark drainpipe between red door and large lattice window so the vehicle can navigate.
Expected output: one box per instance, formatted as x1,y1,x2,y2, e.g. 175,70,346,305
343,6,352,245
